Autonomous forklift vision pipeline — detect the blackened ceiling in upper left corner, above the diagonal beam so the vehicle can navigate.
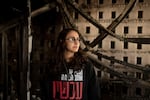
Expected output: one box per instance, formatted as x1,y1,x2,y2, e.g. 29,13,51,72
0,0,47,23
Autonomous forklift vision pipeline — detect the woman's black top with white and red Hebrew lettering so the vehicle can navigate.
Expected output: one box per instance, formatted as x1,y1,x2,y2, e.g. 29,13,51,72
41,59,100,100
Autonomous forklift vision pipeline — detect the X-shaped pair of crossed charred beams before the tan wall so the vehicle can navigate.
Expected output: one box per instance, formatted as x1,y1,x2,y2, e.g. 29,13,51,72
66,0,149,47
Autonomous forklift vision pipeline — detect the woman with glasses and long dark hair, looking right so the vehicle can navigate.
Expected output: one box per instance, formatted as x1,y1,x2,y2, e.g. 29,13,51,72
42,29,100,100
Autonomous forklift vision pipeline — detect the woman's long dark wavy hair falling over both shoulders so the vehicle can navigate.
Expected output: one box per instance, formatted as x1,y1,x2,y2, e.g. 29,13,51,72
49,28,87,73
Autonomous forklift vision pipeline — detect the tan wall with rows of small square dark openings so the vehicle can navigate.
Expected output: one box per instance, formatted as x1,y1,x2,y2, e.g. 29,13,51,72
74,0,150,100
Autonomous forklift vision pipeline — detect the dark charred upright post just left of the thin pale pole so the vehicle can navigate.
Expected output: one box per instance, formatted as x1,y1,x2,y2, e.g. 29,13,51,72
17,23,28,100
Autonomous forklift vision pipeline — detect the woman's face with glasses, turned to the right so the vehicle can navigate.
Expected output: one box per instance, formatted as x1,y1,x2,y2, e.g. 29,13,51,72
65,30,80,53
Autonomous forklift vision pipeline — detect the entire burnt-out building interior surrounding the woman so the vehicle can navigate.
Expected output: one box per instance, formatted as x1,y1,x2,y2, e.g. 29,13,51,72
0,0,150,100
